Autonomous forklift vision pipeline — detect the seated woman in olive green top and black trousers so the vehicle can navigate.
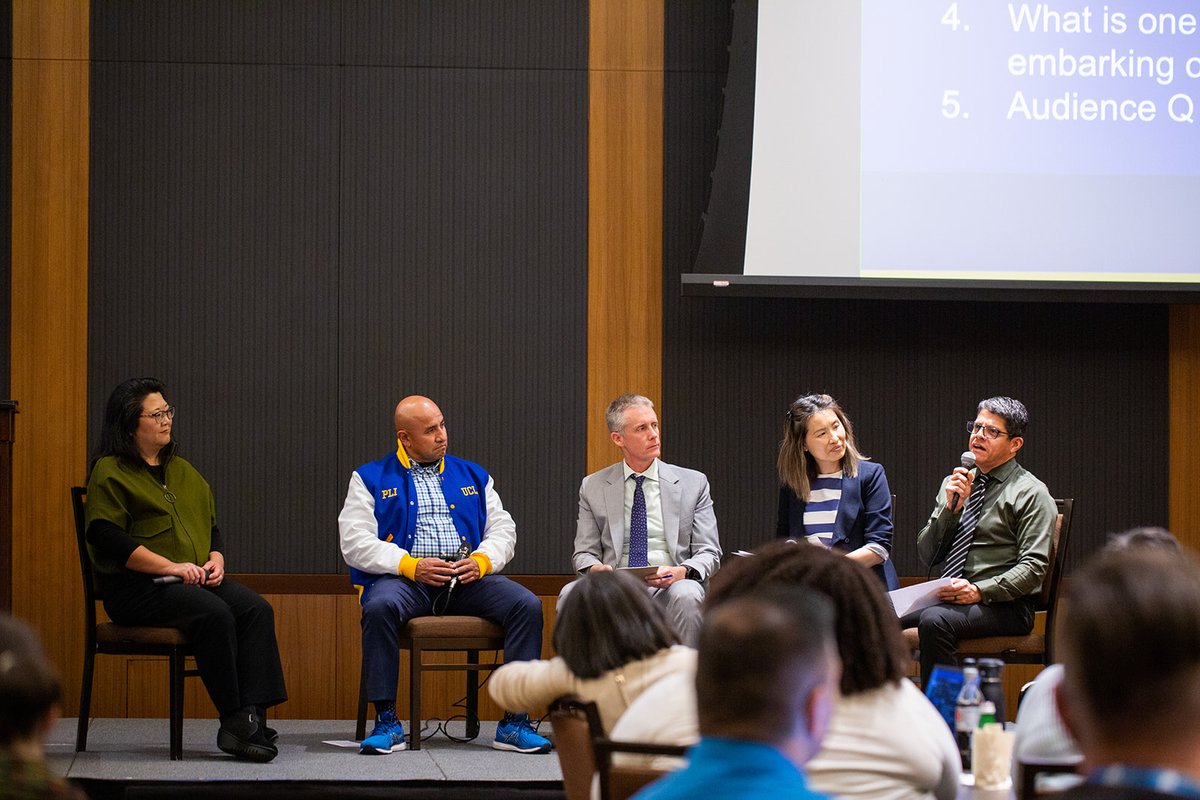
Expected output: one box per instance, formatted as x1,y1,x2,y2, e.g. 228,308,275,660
86,378,287,762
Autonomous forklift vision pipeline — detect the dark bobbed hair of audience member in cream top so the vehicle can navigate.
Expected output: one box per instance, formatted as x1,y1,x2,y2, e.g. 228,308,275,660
554,570,679,678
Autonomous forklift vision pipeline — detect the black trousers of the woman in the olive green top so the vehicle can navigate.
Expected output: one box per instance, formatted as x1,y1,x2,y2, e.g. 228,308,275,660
104,576,288,716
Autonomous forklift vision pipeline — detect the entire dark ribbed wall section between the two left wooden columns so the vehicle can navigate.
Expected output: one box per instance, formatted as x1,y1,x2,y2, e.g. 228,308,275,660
88,0,587,573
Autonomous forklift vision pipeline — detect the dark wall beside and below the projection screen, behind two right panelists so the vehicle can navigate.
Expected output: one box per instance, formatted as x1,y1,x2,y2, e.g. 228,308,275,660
664,2,1168,576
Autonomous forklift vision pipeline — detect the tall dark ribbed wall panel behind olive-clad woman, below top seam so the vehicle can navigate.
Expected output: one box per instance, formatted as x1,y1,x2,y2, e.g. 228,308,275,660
89,62,340,571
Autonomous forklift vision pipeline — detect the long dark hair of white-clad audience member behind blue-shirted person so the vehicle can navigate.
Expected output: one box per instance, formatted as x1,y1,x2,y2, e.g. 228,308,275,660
707,541,911,696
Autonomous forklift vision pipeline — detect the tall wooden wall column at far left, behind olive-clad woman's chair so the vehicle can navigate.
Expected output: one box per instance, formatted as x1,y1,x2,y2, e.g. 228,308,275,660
11,0,89,712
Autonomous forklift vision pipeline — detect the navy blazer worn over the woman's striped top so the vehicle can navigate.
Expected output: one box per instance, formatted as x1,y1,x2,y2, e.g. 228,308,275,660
775,461,900,591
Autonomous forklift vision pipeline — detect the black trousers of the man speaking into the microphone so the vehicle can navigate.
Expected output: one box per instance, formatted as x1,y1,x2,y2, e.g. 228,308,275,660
900,597,1033,686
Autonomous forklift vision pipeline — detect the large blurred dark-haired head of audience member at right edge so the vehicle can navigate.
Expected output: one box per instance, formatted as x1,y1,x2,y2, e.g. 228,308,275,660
1058,546,1200,777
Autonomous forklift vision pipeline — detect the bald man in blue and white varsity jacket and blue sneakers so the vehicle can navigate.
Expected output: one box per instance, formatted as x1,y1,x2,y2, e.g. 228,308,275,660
337,396,551,756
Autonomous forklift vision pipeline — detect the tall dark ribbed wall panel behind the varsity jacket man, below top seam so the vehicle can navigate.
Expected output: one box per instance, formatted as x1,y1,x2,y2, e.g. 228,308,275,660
338,67,587,573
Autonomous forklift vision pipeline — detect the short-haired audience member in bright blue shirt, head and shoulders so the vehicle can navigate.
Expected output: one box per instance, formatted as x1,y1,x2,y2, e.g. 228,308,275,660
635,588,841,800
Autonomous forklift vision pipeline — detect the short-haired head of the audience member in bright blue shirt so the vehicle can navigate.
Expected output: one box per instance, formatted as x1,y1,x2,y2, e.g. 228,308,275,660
696,587,839,765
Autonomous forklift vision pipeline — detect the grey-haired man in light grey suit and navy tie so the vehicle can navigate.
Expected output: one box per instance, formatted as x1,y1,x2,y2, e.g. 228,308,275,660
559,395,721,646
